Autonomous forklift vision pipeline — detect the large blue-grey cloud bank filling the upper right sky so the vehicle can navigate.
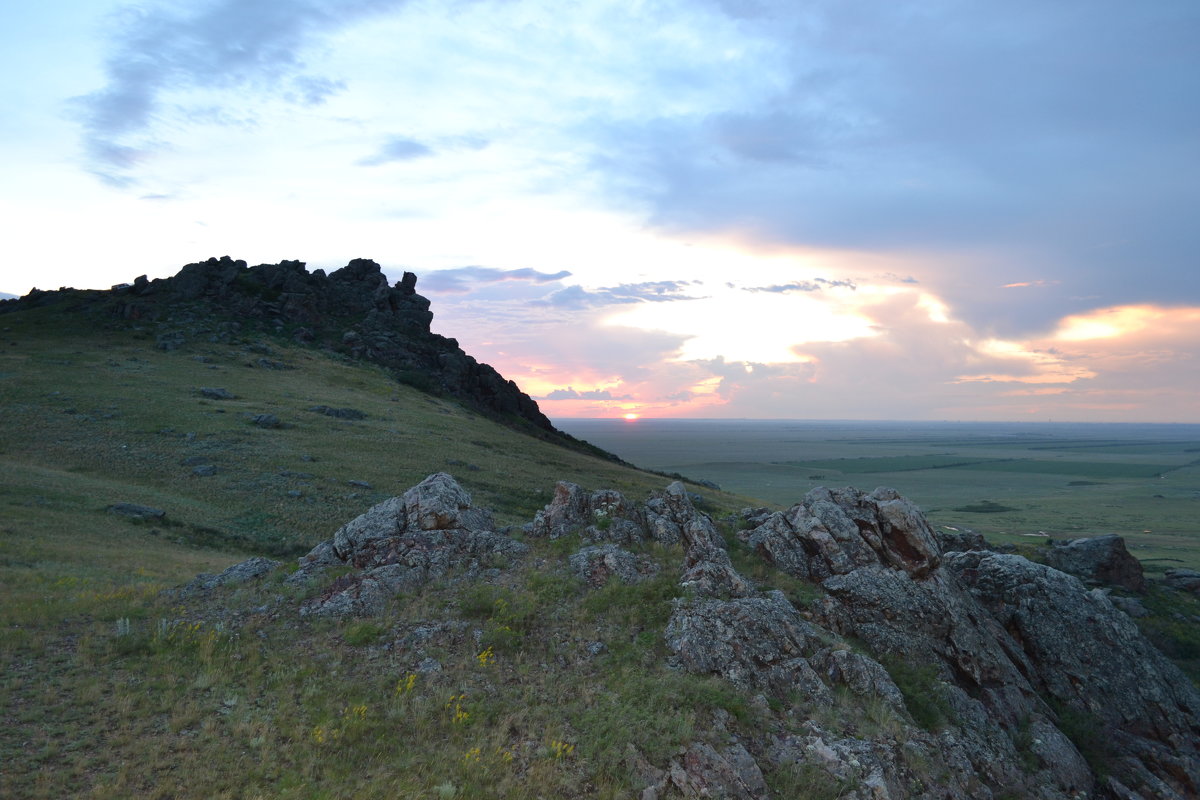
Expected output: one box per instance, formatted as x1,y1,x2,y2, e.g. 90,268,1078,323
596,0,1200,336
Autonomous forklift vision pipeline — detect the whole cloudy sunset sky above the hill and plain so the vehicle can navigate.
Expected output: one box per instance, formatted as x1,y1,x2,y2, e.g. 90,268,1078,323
0,0,1200,422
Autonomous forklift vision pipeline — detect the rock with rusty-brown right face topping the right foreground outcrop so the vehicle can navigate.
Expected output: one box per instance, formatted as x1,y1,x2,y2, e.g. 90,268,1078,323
746,487,940,581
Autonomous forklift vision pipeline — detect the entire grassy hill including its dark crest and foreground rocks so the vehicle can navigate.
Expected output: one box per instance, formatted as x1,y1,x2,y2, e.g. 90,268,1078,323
0,260,1200,800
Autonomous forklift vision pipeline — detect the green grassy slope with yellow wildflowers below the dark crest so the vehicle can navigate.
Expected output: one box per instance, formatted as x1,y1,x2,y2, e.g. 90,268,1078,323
0,303,787,798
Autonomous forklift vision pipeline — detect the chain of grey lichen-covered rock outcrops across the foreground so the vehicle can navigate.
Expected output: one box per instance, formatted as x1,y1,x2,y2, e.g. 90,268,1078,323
201,474,1200,800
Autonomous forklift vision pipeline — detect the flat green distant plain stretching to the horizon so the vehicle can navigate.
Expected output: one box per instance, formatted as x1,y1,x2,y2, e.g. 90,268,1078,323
556,419,1200,573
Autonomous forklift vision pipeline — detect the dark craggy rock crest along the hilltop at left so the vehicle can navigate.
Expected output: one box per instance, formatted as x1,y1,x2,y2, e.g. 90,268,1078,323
0,255,576,441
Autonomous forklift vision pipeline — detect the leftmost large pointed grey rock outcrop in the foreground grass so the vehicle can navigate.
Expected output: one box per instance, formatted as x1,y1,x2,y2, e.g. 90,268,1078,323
301,473,528,615
